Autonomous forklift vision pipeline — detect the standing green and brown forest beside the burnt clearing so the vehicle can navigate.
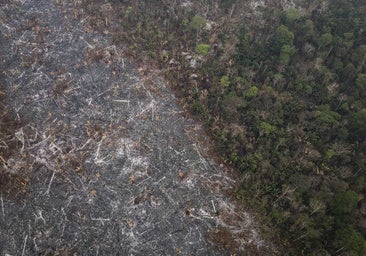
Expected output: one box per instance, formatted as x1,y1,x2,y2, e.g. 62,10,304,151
86,0,366,255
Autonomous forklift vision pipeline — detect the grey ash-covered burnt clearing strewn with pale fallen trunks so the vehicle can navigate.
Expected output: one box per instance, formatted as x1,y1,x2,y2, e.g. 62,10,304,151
0,0,266,255
